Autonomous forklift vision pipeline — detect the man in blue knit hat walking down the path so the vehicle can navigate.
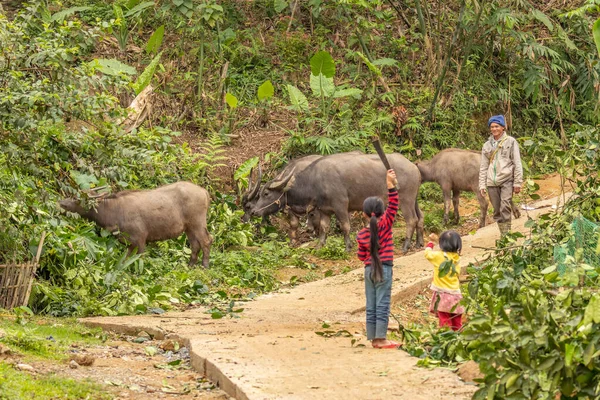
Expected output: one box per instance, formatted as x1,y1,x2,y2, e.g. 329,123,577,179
479,115,523,236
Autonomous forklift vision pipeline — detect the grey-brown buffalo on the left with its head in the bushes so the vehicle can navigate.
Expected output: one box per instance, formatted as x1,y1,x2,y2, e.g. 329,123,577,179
59,182,212,268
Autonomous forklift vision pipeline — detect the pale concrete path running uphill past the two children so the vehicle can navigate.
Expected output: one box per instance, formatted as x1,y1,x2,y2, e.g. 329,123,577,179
82,192,568,400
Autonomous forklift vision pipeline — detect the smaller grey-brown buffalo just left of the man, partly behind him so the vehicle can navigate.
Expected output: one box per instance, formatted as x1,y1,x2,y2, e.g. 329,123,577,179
417,149,521,228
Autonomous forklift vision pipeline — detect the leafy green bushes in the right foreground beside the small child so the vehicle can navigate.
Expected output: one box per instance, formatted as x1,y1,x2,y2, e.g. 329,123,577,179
403,129,600,399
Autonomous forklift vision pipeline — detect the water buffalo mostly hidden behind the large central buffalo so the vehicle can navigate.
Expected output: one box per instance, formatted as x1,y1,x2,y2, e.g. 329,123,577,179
242,155,323,243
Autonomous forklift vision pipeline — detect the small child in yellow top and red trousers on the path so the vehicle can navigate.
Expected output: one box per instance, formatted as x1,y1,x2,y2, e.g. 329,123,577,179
425,231,465,331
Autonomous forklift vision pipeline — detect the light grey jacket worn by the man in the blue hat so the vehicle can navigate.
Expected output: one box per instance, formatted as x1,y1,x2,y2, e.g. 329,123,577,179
479,133,523,189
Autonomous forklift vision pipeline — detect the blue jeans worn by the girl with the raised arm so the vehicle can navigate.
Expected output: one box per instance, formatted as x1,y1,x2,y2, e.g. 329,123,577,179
365,264,393,340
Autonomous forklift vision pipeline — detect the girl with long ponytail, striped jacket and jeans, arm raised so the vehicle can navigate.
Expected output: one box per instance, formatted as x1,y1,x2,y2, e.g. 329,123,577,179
356,169,400,349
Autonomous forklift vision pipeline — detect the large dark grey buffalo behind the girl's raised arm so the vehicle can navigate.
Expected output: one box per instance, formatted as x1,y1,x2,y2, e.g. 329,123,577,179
252,152,423,251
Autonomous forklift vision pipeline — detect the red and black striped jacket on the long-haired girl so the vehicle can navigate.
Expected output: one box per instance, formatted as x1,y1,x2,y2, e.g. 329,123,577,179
356,189,398,267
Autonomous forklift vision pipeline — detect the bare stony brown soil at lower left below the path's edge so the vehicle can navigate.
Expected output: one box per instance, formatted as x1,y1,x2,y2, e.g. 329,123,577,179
0,335,230,400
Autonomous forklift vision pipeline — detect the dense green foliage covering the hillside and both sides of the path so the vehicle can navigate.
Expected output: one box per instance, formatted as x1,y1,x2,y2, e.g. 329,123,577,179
0,0,600,398
